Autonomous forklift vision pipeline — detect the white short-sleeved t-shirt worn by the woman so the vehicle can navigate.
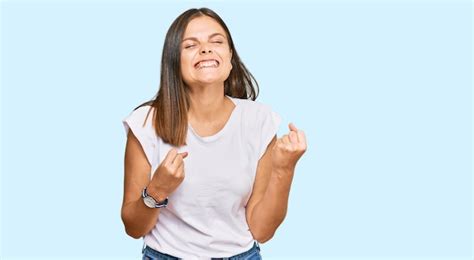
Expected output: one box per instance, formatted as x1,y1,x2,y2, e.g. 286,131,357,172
123,95,281,259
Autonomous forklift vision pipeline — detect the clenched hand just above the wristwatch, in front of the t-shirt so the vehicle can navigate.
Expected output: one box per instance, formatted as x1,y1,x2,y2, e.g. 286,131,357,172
147,148,188,201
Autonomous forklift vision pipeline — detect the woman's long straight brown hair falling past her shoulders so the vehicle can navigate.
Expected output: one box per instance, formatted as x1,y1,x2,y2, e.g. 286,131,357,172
135,8,258,146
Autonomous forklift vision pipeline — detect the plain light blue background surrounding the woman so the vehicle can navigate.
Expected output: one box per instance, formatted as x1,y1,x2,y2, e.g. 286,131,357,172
0,0,473,259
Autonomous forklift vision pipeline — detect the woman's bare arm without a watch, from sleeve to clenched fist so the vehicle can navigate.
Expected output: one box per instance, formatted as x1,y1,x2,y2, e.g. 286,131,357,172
246,124,306,243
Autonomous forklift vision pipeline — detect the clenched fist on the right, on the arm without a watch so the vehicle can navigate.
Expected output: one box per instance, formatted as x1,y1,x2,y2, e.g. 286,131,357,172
272,123,307,171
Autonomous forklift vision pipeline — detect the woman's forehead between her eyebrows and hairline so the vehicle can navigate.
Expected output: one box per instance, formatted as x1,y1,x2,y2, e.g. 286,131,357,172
184,16,226,38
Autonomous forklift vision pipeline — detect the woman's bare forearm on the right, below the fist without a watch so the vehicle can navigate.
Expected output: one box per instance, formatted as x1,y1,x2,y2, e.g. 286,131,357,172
250,169,294,242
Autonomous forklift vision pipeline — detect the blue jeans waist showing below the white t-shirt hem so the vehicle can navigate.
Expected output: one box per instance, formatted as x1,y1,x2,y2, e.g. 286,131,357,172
142,242,262,260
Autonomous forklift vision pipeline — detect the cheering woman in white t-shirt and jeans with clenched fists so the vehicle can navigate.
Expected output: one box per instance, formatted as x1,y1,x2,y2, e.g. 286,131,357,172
122,8,306,259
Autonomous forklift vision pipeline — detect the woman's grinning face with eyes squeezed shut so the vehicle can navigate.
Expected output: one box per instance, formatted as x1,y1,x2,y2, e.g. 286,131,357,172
181,16,232,86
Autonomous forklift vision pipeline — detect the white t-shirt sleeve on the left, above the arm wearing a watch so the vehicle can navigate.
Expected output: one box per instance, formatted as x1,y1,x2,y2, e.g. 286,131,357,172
122,106,156,165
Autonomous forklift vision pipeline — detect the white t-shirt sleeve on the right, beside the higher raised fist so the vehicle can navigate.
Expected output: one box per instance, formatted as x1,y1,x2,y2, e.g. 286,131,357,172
256,106,281,159
